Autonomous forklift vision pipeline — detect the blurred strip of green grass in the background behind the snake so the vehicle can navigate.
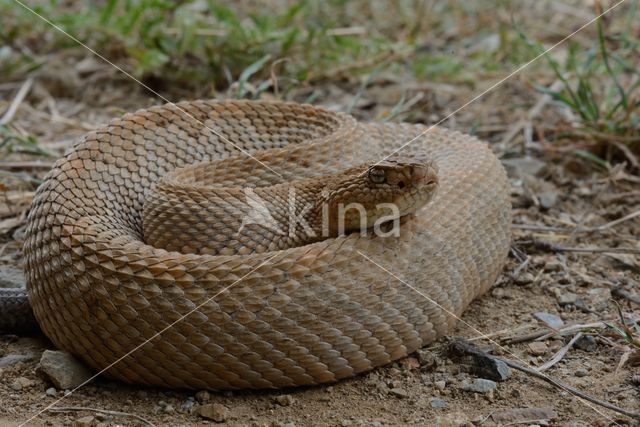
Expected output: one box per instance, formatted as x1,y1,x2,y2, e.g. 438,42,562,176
0,0,524,97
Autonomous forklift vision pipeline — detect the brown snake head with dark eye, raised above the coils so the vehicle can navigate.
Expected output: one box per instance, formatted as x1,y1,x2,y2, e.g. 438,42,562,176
322,155,438,236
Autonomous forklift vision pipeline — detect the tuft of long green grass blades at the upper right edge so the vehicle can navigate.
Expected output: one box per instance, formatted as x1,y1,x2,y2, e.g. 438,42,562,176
527,8,640,163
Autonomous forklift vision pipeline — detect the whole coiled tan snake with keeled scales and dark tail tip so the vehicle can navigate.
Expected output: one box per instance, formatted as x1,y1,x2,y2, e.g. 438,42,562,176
0,100,511,390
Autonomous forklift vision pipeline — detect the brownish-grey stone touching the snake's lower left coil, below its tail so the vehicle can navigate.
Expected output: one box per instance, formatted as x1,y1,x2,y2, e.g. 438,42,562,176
40,350,91,390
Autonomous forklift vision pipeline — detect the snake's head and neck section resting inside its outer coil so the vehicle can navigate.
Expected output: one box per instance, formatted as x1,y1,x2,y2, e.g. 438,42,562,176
142,156,438,255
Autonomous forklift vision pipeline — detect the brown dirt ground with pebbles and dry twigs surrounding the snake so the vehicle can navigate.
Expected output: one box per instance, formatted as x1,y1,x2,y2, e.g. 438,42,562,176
0,41,640,427
